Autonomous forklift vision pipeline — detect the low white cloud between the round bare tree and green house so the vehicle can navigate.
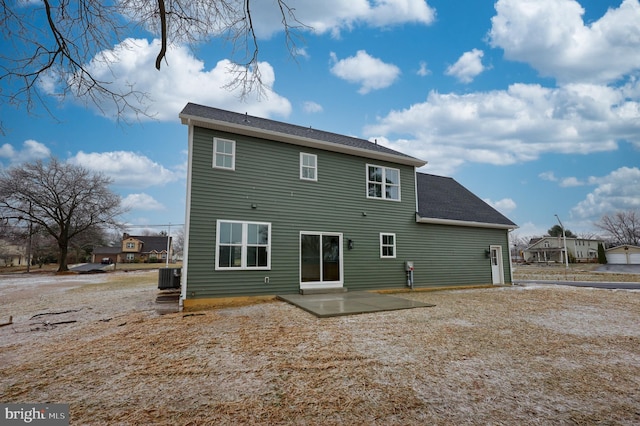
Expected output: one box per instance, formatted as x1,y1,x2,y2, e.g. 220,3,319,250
68,151,182,188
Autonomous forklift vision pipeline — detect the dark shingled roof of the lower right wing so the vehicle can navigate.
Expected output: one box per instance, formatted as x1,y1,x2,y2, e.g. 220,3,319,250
416,173,517,228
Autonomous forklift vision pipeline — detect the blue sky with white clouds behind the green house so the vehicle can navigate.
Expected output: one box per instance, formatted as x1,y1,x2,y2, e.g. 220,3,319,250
0,0,640,237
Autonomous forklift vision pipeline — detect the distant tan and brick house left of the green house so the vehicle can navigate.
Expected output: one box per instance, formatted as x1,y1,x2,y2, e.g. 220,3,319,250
93,233,173,263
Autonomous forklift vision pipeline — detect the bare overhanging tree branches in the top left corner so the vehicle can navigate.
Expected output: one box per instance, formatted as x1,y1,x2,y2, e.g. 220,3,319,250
0,0,305,130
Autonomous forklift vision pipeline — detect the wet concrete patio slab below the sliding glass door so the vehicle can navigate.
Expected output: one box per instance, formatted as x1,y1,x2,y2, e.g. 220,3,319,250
277,291,435,318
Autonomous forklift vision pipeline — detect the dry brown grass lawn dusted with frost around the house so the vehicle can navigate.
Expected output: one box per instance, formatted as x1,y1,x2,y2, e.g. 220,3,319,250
0,266,640,425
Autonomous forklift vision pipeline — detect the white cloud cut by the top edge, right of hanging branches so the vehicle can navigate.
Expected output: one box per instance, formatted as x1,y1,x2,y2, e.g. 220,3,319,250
252,0,435,38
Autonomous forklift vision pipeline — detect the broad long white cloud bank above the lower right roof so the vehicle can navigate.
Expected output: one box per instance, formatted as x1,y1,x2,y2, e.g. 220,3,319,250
364,84,640,177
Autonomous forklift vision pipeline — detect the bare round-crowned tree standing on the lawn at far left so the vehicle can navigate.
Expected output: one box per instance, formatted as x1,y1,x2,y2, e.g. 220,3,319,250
0,157,125,272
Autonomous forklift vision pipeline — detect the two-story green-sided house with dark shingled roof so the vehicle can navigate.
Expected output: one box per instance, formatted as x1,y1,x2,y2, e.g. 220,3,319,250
180,103,516,309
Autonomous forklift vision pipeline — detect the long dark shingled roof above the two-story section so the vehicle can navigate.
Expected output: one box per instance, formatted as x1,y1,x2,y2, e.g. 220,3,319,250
180,103,425,163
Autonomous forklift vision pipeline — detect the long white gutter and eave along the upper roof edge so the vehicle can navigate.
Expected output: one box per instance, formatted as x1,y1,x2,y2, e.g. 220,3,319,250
179,114,427,167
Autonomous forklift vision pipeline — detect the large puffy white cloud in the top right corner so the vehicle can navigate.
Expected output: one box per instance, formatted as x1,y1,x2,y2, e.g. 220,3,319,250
489,0,640,83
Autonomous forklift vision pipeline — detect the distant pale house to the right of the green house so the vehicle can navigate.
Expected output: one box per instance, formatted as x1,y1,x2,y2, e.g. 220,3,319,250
524,236,604,263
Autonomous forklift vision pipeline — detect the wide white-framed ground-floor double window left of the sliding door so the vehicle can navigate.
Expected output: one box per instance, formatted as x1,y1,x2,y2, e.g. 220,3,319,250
216,220,271,270
